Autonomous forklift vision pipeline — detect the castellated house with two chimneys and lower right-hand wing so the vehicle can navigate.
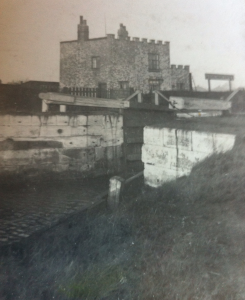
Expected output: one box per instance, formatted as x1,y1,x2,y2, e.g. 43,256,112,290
60,17,190,92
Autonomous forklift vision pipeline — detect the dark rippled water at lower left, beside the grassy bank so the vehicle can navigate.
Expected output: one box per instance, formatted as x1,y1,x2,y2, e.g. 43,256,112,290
0,178,108,246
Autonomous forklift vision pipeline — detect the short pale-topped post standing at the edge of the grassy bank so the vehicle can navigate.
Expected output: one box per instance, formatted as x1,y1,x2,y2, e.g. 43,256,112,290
107,176,124,211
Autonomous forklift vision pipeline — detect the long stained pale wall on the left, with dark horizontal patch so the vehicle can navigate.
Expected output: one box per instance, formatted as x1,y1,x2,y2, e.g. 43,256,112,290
0,113,123,175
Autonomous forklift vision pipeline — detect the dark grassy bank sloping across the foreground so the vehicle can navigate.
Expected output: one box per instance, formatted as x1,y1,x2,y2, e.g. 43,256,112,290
0,116,245,300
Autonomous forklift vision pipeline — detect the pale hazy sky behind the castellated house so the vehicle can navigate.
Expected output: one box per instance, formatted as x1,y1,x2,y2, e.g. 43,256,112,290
0,0,245,87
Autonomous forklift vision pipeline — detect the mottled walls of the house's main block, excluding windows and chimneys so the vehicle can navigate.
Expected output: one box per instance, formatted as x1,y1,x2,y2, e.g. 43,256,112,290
60,35,171,92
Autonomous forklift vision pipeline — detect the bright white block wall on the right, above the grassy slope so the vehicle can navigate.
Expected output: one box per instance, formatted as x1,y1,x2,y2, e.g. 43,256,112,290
142,127,235,187
